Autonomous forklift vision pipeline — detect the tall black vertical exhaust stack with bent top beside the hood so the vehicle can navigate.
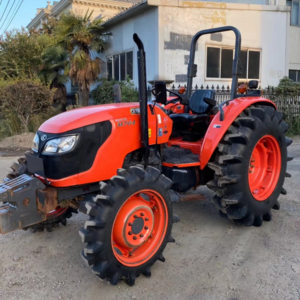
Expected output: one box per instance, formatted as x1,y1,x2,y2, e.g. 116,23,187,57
133,33,149,167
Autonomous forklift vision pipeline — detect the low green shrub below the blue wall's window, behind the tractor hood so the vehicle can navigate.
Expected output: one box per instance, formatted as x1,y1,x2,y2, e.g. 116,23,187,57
92,76,139,104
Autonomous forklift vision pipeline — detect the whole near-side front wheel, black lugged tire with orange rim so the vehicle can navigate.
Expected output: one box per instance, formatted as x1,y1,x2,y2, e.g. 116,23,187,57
79,165,177,286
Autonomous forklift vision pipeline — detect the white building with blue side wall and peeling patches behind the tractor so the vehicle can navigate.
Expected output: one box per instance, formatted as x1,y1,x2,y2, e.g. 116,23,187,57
104,0,300,87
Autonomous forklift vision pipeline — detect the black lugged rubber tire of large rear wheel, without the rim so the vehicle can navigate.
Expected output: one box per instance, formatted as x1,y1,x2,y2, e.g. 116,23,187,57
207,105,292,227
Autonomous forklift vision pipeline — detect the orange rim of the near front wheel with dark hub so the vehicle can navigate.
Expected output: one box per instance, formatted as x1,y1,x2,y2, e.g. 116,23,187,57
111,190,168,267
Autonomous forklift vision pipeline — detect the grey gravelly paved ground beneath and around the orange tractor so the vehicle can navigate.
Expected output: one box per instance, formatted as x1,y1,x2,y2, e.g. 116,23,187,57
0,140,300,300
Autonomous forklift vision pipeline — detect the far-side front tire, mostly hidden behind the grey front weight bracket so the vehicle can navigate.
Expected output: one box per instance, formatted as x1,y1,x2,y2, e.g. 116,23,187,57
4,157,78,233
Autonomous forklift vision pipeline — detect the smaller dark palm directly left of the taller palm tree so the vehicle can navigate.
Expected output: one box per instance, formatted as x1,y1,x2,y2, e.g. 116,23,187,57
39,46,69,111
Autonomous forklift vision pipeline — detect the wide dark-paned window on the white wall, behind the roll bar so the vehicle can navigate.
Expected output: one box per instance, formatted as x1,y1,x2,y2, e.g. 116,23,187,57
206,47,260,79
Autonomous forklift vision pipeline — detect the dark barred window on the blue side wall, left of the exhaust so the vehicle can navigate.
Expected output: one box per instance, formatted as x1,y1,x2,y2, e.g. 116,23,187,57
107,51,133,81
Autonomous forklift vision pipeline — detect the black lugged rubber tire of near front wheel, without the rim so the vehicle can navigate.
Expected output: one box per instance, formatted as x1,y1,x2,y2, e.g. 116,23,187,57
79,165,178,286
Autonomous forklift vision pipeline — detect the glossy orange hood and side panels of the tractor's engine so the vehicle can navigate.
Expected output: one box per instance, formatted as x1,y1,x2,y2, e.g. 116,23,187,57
43,103,173,187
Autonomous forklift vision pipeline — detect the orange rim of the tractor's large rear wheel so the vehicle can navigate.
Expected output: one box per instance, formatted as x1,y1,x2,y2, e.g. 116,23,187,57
248,135,281,201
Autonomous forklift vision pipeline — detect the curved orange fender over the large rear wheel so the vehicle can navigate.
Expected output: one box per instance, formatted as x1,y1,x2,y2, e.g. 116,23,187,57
200,97,276,170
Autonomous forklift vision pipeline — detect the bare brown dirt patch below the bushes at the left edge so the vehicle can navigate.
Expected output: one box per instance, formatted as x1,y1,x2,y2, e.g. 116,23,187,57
0,132,34,156
